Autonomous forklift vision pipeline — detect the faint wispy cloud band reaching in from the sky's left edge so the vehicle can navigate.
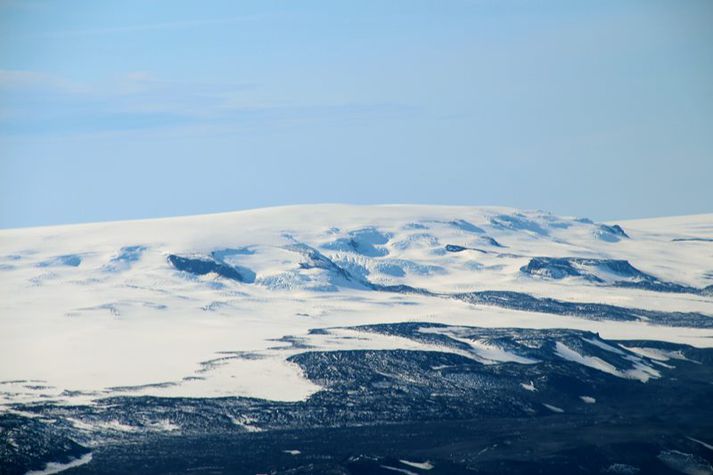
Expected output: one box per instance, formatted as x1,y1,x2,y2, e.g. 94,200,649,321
0,70,414,137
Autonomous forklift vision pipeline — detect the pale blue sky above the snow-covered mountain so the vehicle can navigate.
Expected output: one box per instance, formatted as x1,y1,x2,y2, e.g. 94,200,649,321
0,0,713,228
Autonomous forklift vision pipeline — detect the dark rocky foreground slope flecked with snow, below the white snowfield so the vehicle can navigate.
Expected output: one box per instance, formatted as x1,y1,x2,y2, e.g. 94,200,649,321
0,323,713,475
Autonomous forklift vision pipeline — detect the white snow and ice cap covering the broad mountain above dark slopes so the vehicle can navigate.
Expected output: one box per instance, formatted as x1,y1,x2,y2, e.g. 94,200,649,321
0,205,713,410
